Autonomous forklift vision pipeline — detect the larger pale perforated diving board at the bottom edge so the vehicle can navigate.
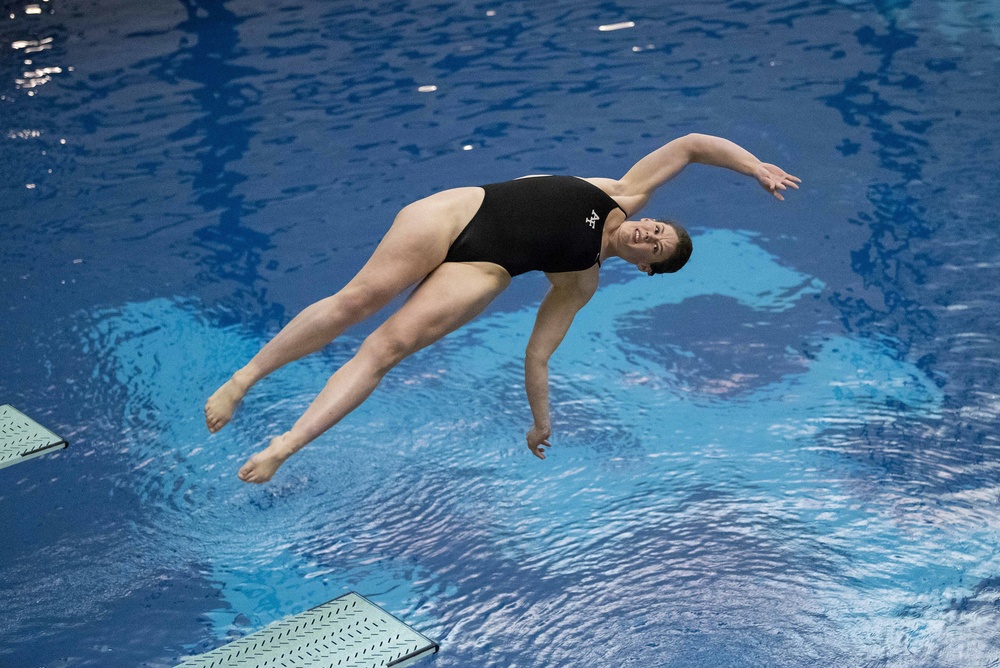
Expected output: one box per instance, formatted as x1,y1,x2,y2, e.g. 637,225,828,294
176,592,438,668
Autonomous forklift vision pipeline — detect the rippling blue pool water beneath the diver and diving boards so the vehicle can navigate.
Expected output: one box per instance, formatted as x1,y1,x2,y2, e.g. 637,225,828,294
0,0,1000,668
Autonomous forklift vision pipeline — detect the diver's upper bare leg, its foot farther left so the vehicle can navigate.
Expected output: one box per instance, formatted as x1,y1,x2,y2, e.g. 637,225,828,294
205,188,481,433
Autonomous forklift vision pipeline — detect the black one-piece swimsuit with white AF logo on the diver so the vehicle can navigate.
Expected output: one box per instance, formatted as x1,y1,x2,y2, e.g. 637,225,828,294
444,176,624,276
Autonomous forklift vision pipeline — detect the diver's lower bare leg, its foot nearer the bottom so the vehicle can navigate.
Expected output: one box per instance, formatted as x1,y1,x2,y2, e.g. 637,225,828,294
239,262,510,483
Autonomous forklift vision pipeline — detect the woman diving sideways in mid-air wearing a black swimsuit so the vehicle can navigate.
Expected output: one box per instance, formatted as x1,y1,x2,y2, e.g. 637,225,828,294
205,134,801,483
